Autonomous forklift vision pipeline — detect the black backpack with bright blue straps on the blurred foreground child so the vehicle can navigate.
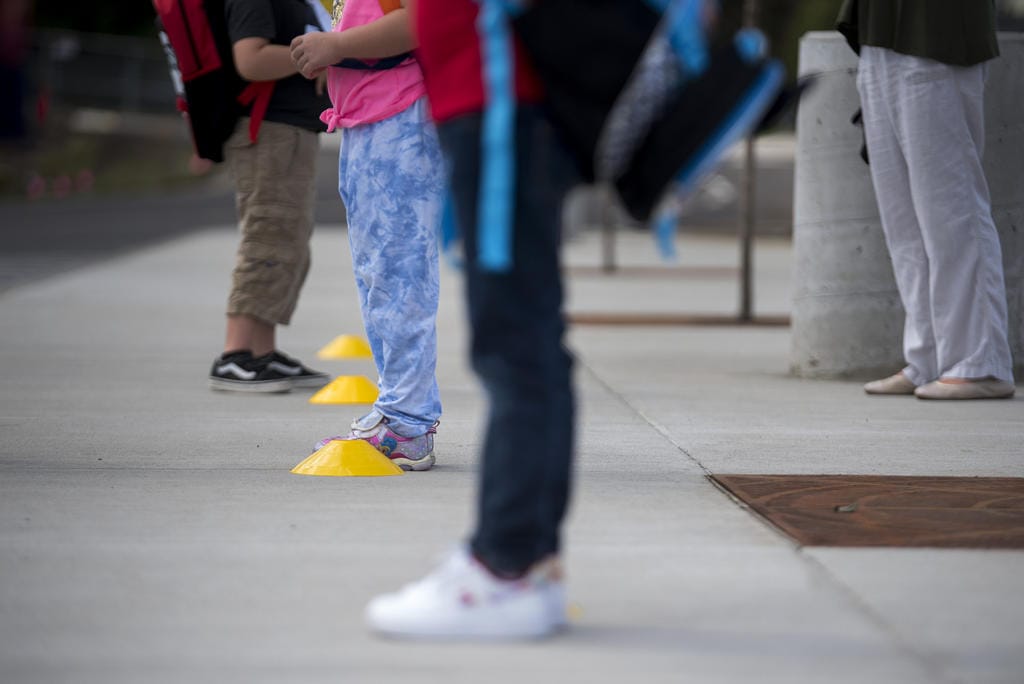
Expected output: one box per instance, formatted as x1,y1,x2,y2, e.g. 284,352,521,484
466,0,802,271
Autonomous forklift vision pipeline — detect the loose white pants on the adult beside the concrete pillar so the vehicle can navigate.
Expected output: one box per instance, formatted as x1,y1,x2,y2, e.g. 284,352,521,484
857,47,1013,385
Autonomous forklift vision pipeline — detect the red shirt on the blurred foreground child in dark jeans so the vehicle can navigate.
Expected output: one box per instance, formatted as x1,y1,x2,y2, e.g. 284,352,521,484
413,0,541,122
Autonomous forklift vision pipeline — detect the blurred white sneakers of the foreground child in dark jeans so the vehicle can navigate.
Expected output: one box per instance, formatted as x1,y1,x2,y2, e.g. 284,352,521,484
366,549,566,639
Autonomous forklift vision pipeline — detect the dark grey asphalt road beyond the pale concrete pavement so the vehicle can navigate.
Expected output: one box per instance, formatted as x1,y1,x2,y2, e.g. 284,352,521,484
0,138,793,292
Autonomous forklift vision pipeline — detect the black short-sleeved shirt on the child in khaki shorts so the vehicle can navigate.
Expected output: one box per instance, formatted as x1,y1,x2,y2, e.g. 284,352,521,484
224,0,331,131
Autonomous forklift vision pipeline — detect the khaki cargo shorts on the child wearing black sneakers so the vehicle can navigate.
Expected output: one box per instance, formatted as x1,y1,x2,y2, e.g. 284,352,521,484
224,118,317,325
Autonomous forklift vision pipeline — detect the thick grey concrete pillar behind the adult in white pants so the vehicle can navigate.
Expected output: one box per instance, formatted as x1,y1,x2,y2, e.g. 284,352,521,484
790,32,1024,380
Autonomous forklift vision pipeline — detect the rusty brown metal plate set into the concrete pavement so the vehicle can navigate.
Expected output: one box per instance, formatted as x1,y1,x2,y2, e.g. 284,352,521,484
712,475,1024,549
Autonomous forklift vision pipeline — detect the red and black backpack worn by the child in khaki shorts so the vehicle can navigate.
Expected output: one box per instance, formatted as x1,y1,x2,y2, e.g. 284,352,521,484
153,0,274,162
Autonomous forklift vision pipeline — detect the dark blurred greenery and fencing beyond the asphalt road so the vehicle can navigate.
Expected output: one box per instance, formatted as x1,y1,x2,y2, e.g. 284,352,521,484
0,0,1024,201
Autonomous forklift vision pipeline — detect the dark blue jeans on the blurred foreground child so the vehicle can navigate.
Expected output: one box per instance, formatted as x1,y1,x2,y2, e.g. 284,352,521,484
438,108,574,575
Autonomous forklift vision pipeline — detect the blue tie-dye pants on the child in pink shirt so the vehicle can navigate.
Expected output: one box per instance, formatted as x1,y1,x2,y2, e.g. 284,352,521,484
339,100,444,437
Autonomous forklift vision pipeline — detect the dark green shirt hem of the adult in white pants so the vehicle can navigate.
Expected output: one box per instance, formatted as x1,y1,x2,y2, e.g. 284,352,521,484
836,0,999,67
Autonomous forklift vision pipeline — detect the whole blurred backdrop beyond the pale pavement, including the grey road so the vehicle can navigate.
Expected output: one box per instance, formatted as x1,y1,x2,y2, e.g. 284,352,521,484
0,0,1024,290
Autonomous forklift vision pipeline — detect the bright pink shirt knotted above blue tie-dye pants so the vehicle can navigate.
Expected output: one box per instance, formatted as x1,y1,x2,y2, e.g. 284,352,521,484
321,0,426,133
